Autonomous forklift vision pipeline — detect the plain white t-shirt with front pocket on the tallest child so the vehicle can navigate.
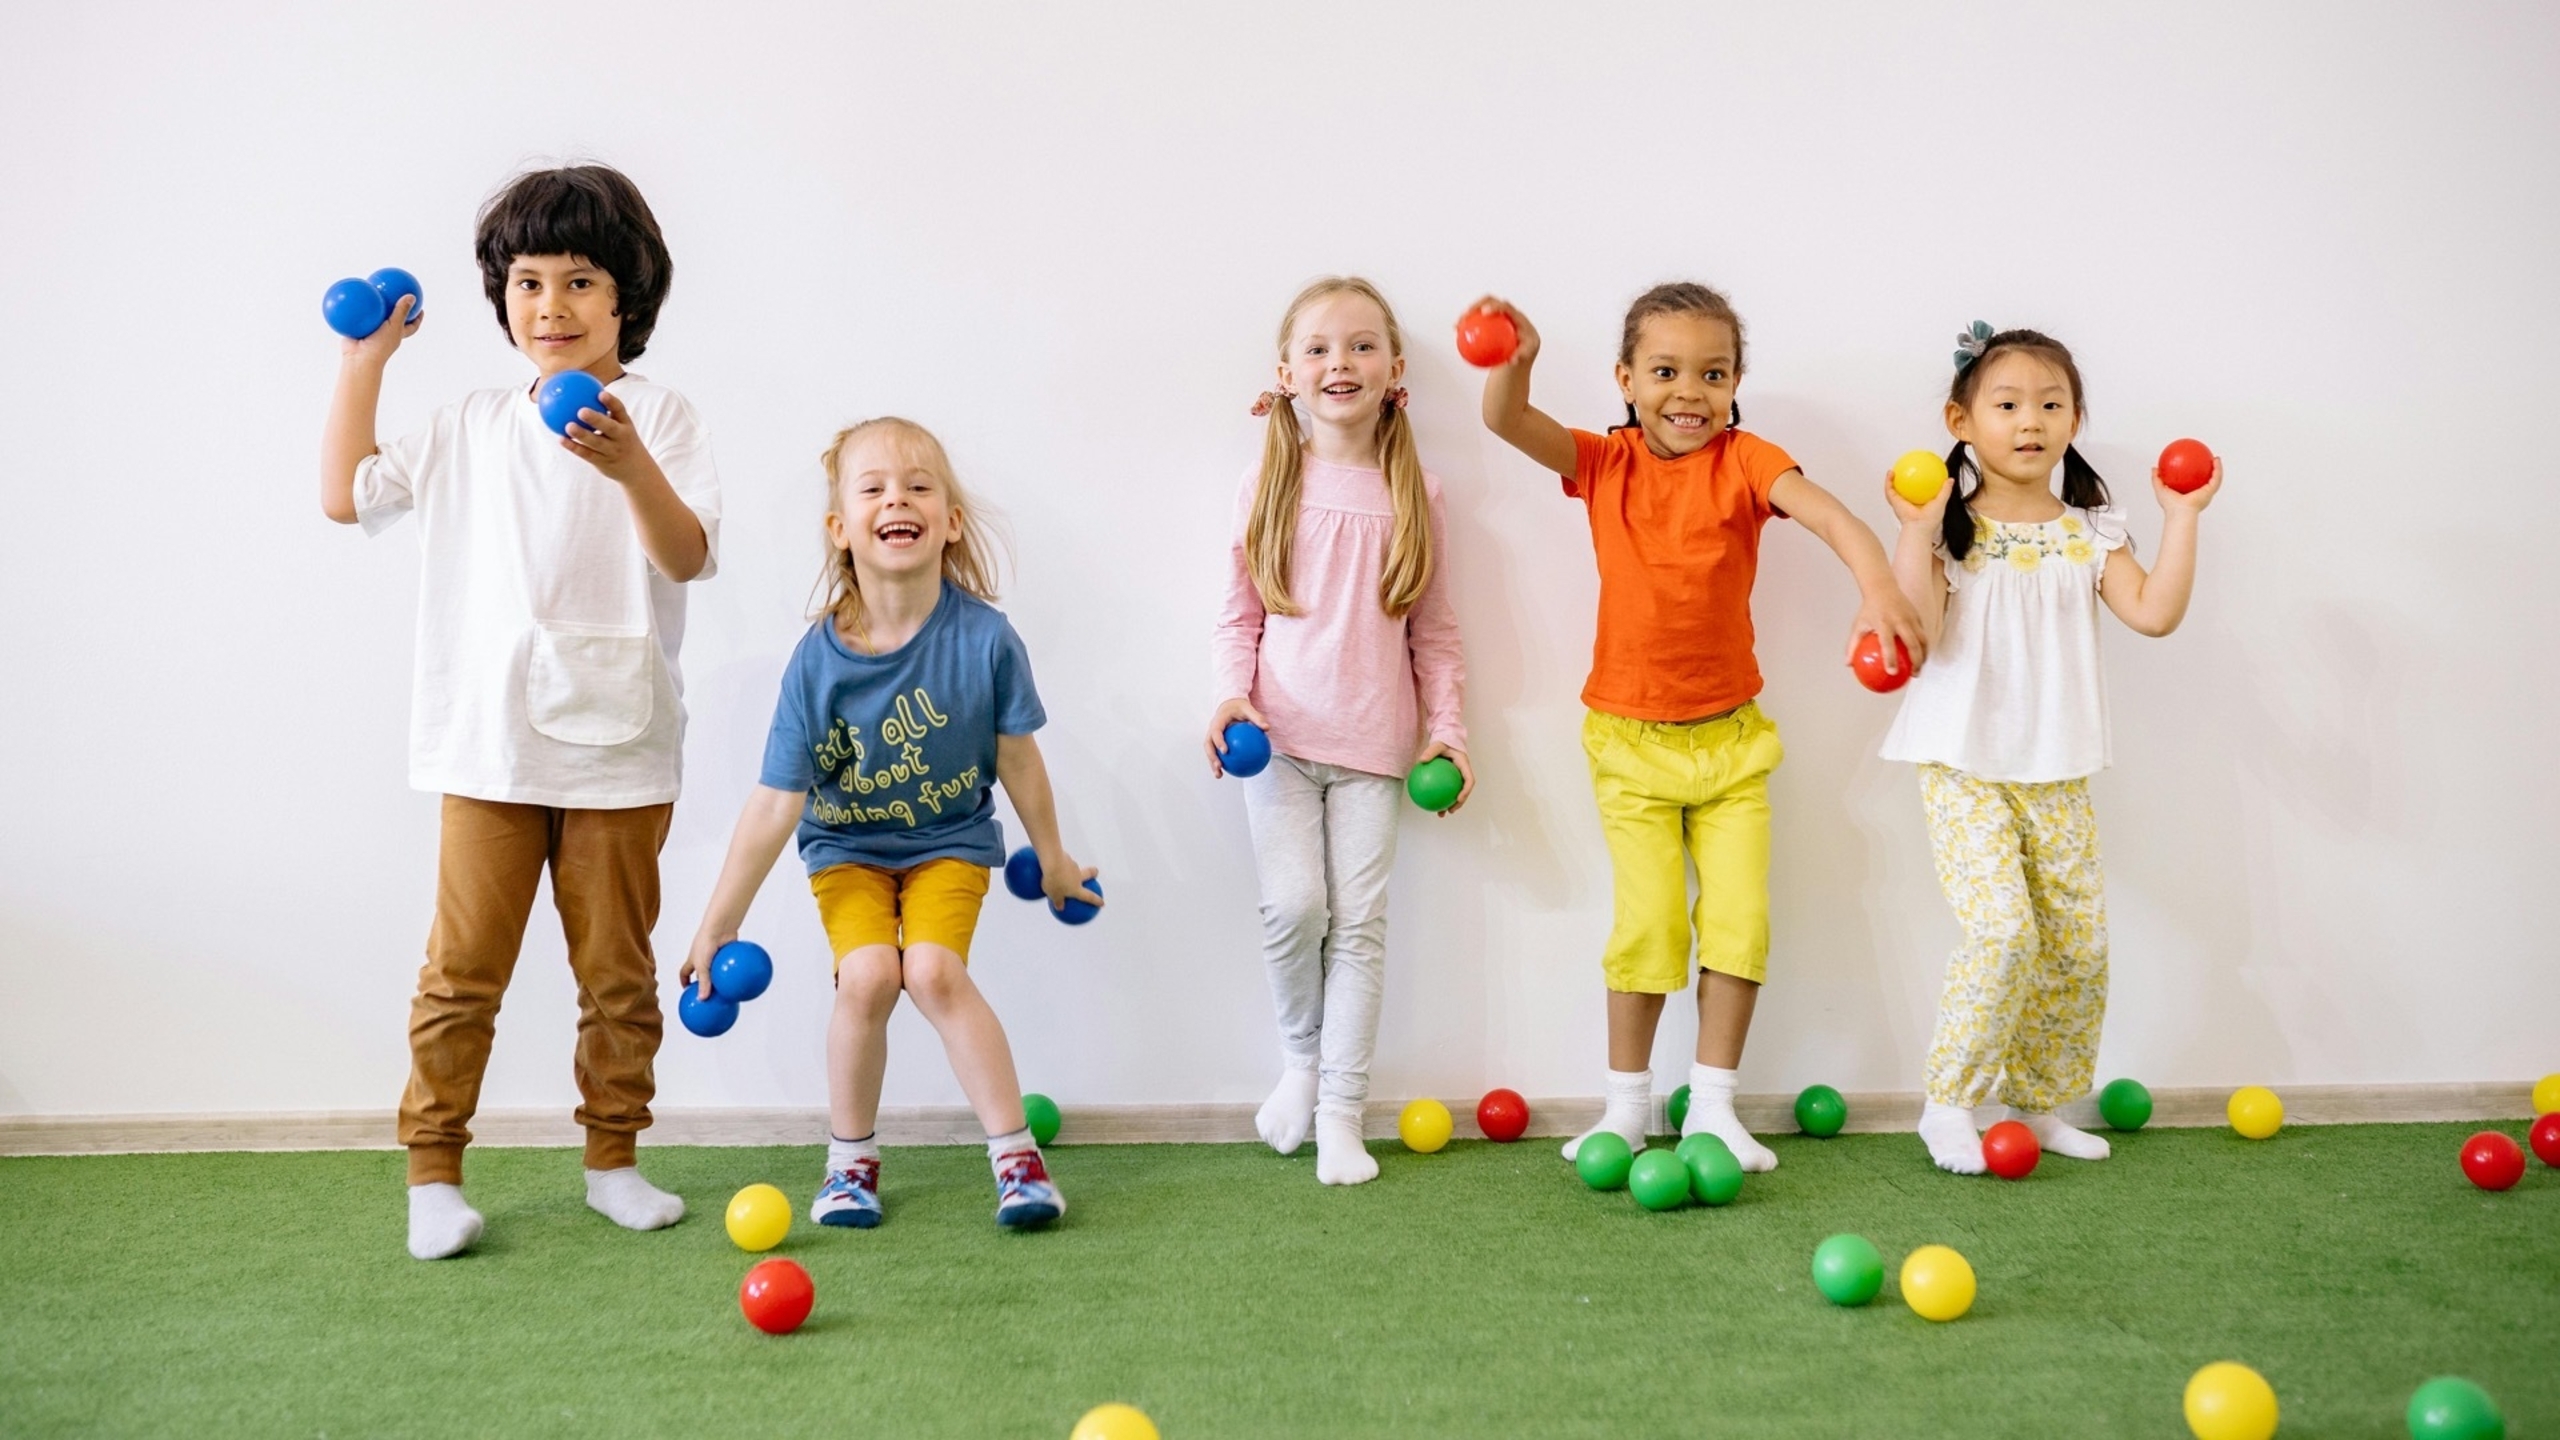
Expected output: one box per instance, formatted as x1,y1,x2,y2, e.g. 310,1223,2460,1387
356,374,719,810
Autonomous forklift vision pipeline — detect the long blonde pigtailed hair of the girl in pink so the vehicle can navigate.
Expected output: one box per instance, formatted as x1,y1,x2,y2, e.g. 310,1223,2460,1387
1244,274,1431,618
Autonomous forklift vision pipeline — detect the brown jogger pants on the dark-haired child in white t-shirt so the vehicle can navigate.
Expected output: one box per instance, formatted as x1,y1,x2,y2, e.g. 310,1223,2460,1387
399,794,676,1184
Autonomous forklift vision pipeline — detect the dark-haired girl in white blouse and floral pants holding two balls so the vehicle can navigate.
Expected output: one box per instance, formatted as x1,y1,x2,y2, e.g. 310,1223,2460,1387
1884,325,2222,1176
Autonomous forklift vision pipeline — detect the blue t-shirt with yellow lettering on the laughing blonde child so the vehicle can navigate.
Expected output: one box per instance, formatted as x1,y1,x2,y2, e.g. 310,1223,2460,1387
763,584,1047,874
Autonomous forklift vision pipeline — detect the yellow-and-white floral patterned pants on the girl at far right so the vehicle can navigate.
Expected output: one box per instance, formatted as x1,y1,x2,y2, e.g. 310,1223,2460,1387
1920,764,2107,1109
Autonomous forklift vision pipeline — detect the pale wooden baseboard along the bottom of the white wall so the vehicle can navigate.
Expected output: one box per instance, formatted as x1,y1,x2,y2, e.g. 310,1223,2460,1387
0,1081,2532,1156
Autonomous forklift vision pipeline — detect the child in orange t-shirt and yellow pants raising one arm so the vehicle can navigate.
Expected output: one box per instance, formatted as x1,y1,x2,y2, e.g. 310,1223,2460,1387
1477,284,1925,1171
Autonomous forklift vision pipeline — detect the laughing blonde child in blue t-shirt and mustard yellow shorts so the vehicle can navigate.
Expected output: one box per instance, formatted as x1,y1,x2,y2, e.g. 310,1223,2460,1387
684,418,1101,1227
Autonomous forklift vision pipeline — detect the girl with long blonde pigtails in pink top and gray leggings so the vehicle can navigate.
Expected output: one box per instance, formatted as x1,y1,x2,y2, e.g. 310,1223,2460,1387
1208,279,1475,1184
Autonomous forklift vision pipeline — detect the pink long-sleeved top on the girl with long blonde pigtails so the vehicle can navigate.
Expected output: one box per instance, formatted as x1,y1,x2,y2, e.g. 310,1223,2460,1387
1211,456,1467,776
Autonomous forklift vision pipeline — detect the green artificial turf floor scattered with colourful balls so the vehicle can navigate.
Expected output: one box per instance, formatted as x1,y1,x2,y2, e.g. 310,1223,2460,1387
0,1125,2560,1440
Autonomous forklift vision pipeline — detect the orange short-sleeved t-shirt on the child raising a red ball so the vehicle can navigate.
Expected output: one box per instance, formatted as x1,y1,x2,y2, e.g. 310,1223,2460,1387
1564,425,1795,720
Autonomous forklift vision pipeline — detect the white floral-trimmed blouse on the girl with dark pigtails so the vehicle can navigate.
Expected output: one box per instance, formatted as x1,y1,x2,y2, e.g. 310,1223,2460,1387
1882,505,2127,784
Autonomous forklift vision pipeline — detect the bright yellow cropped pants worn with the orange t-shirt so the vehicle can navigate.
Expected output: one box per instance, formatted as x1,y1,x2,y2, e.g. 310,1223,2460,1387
1582,705,1787,994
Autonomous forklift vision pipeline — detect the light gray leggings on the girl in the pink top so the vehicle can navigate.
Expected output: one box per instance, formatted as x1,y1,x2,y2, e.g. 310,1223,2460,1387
1244,756,1403,1112
